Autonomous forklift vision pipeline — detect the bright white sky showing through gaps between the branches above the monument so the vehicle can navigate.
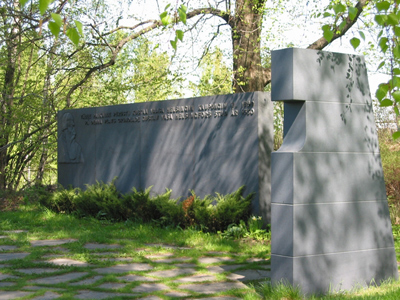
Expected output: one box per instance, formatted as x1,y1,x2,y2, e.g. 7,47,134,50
117,0,388,95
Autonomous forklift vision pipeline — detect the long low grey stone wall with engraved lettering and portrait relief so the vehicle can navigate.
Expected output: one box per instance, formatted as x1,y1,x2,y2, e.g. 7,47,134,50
58,92,273,222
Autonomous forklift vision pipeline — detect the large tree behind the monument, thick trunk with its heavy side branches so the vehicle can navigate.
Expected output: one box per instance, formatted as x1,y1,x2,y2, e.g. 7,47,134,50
178,0,368,93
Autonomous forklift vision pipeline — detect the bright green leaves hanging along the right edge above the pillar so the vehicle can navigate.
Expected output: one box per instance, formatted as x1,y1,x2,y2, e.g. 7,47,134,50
322,0,400,139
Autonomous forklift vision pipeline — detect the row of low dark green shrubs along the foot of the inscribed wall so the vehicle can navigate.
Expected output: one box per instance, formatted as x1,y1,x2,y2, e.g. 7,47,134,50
39,181,254,232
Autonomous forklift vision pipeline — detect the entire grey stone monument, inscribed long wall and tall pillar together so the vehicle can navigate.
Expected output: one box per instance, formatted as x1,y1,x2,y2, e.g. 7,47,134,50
58,48,398,294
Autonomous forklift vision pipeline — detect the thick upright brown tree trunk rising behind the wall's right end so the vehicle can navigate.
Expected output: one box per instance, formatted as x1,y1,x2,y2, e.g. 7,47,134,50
229,0,265,93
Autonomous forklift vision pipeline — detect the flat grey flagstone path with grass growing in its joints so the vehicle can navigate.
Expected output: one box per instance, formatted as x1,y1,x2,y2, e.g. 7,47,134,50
0,231,270,300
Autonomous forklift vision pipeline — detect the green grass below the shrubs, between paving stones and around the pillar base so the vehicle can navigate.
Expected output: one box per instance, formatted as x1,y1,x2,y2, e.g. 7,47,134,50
0,205,400,300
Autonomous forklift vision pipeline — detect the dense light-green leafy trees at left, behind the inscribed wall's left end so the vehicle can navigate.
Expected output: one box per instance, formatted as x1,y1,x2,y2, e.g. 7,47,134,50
0,0,185,190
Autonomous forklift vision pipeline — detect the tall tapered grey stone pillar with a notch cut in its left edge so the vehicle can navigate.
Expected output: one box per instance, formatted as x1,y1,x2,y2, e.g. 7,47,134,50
271,48,398,294
